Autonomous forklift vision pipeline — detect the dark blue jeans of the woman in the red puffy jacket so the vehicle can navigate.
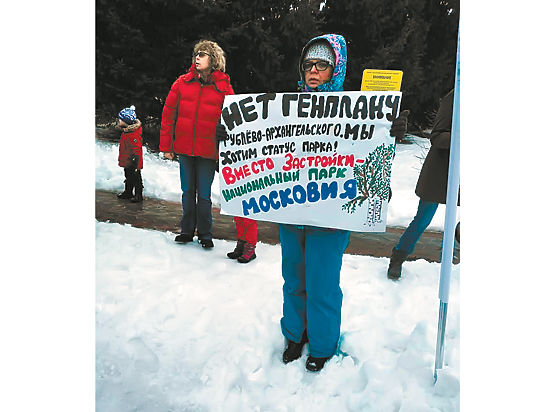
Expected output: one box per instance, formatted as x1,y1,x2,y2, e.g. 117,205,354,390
178,155,216,240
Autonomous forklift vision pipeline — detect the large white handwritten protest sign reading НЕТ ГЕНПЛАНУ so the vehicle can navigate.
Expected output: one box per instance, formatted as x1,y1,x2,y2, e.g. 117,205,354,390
219,91,401,232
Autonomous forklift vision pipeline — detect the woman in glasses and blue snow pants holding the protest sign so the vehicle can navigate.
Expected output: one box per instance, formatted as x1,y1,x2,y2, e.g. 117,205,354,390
279,34,406,371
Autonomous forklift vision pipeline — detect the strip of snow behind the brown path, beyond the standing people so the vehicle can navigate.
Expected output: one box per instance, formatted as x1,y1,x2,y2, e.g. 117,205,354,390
95,137,458,231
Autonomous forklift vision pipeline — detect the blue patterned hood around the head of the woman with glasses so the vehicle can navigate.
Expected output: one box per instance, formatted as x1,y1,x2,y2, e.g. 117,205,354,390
298,34,348,92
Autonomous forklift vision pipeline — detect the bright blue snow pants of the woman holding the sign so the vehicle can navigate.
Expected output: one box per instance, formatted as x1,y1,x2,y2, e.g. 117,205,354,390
279,224,350,358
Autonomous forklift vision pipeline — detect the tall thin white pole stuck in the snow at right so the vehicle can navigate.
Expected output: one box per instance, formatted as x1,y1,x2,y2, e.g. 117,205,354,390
434,25,460,381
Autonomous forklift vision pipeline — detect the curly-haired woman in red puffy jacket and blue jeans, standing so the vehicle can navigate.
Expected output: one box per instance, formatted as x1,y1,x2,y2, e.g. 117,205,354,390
160,40,234,249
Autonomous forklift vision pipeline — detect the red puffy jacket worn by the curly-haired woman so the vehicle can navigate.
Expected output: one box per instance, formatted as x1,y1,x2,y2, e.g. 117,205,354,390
160,65,234,159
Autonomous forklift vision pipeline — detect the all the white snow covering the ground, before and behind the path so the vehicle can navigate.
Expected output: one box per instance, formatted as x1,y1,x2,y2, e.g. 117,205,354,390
95,137,460,412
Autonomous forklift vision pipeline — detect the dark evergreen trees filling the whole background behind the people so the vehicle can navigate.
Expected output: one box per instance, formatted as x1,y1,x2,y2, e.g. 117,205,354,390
96,0,459,148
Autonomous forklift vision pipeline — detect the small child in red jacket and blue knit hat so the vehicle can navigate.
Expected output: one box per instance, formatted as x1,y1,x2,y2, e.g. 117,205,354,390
117,106,143,203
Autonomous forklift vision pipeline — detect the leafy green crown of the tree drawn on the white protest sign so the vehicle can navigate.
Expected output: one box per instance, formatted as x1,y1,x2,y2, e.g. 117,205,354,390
342,144,395,213
